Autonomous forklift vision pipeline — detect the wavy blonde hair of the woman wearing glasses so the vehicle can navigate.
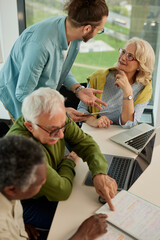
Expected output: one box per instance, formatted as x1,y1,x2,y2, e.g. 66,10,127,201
125,37,155,85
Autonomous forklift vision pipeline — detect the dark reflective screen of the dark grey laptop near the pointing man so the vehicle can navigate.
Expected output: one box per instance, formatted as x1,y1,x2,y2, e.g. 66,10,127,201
136,134,156,167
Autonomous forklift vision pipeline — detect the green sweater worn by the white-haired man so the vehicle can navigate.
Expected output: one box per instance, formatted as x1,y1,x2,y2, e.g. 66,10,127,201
7,116,108,201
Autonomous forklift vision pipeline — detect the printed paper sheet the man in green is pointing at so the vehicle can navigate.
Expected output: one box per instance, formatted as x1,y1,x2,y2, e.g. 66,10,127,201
96,190,160,240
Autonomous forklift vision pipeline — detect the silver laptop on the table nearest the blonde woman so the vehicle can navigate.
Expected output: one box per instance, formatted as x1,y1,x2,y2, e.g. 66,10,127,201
110,123,154,154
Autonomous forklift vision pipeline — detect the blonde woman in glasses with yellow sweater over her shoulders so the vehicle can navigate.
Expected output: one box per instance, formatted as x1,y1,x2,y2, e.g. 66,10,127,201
78,38,155,128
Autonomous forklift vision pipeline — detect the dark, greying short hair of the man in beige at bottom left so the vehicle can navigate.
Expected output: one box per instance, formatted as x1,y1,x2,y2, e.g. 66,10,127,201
0,135,45,192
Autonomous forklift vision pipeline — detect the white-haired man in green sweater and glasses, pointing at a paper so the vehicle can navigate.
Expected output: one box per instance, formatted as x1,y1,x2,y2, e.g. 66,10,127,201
8,88,117,232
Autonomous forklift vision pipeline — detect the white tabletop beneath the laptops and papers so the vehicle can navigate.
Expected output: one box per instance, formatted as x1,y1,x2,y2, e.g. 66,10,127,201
48,124,160,240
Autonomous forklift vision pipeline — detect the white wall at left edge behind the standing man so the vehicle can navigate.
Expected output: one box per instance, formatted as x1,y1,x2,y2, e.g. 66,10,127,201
0,0,19,119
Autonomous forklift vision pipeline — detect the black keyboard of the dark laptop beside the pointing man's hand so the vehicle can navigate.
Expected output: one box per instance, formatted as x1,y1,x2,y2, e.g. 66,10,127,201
108,157,131,189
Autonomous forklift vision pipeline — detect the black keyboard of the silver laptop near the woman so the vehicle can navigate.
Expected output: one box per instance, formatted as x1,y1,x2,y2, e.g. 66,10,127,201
125,129,154,150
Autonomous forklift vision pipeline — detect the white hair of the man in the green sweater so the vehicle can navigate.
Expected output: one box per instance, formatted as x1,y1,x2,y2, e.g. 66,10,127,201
22,87,64,123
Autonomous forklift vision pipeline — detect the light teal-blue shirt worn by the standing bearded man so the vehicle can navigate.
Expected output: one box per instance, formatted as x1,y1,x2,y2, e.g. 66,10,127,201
0,17,81,119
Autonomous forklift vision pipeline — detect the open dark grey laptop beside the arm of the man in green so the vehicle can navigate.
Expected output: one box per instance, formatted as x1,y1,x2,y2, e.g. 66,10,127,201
84,128,156,190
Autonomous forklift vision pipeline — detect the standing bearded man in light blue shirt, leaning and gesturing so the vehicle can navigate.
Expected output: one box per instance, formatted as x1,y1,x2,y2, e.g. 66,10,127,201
0,0,108,121
